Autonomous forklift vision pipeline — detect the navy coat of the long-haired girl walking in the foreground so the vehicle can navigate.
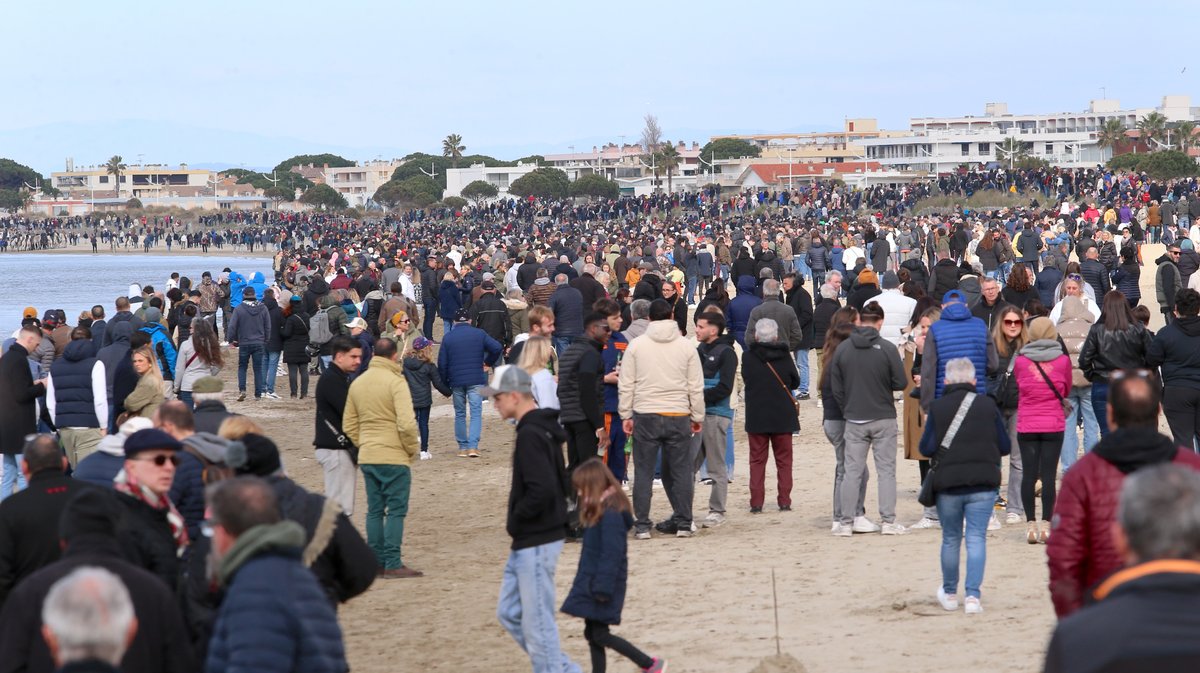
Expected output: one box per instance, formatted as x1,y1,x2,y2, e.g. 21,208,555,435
563,509,634,624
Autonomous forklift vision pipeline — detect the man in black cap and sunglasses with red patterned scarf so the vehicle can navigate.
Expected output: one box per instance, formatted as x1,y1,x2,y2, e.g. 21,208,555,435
113,428,188,587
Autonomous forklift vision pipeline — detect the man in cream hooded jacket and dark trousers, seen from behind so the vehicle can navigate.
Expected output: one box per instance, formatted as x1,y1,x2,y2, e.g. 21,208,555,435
617,299,704,540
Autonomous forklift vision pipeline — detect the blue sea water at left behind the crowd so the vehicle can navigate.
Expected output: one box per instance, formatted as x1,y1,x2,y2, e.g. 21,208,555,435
0,253,274,337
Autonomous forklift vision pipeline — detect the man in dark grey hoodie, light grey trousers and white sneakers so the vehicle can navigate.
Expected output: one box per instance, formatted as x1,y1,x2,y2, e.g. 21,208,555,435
829,301,907,537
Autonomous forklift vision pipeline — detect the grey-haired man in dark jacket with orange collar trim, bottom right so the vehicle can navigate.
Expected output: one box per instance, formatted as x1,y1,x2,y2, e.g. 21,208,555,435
1043,464,1200,673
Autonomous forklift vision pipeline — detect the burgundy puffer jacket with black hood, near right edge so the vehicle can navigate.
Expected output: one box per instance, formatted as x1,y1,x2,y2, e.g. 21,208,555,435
1046,428,1200,619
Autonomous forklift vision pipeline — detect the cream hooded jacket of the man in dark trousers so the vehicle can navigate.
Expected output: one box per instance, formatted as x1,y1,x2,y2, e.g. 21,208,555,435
617,320,704,422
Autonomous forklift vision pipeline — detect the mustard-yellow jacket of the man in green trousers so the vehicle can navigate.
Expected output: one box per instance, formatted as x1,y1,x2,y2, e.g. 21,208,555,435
342,356,421,465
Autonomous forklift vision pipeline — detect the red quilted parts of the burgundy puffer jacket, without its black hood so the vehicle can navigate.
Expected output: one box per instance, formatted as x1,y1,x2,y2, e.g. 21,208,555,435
1046,435,1200,619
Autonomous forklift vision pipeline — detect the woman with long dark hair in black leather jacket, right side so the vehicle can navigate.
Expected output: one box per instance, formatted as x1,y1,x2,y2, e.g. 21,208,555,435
1079,290,1153,439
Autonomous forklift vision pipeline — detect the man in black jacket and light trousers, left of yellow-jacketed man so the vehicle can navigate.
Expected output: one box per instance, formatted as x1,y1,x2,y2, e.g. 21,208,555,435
312,336,362,516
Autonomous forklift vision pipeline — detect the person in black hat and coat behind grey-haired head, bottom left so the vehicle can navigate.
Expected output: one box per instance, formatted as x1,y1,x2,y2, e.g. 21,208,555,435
0,488,198,673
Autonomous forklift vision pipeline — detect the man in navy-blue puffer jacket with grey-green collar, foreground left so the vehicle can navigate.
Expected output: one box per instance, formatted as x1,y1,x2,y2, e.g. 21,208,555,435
204,476,349,673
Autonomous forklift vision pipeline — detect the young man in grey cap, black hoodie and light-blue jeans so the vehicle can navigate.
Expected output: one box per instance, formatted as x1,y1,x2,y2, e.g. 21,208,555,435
481,365,580,671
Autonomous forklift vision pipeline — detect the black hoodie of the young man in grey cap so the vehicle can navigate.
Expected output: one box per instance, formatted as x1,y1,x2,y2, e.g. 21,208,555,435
505,409,568,551
